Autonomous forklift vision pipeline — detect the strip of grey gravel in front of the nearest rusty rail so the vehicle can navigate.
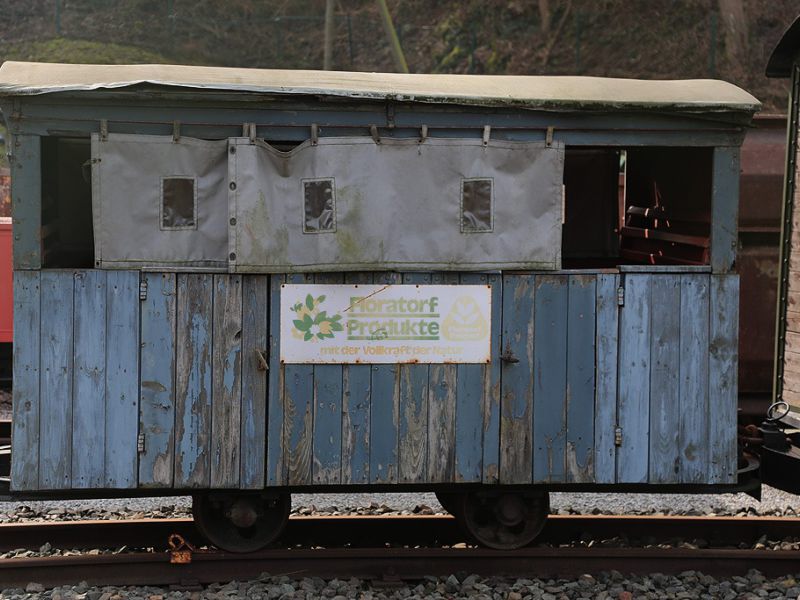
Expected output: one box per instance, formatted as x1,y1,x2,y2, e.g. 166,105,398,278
0,571,800,600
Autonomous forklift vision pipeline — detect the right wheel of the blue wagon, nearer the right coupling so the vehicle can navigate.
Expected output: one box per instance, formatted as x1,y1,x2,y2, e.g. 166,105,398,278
456,491,550,550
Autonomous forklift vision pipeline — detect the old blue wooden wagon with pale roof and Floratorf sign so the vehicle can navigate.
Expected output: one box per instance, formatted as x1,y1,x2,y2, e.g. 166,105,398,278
0,62,759,550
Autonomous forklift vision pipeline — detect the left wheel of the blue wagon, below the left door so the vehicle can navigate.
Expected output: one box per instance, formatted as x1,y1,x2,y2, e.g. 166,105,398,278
192,492,292,552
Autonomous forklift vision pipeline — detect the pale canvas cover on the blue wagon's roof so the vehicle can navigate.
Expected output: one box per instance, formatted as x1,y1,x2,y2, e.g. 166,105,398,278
0,61,760,113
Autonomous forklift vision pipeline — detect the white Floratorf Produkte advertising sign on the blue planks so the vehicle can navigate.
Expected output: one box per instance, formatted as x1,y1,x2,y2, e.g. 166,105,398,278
280,284,492,363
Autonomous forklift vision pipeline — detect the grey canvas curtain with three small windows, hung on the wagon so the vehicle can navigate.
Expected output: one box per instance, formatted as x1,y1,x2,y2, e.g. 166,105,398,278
92,135,564,273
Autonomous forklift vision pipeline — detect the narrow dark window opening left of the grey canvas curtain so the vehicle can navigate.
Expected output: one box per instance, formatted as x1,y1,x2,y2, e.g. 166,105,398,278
41,137,94,269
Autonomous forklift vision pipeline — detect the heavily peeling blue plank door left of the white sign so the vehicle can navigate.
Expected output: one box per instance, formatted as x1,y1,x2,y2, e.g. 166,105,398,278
139,273,268,489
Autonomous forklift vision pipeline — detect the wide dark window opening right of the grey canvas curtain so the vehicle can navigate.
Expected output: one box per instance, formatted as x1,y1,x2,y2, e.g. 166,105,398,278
562,147,713,268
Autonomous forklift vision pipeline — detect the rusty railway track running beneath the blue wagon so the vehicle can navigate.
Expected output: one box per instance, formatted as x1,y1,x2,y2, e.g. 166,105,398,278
0,516,800,588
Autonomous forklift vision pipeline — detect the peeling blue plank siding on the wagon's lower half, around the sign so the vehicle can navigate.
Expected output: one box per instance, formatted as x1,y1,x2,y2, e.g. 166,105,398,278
12,270,736,491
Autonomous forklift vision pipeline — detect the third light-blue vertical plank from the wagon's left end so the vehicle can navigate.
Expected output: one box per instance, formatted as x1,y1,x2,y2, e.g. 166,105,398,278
72,270,106,488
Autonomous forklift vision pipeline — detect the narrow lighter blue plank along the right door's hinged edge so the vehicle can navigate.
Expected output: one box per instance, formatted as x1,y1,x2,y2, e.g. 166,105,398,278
594,274,619,483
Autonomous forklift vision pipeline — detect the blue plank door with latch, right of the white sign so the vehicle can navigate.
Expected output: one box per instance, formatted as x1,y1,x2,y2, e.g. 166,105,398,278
500,274,617,484
